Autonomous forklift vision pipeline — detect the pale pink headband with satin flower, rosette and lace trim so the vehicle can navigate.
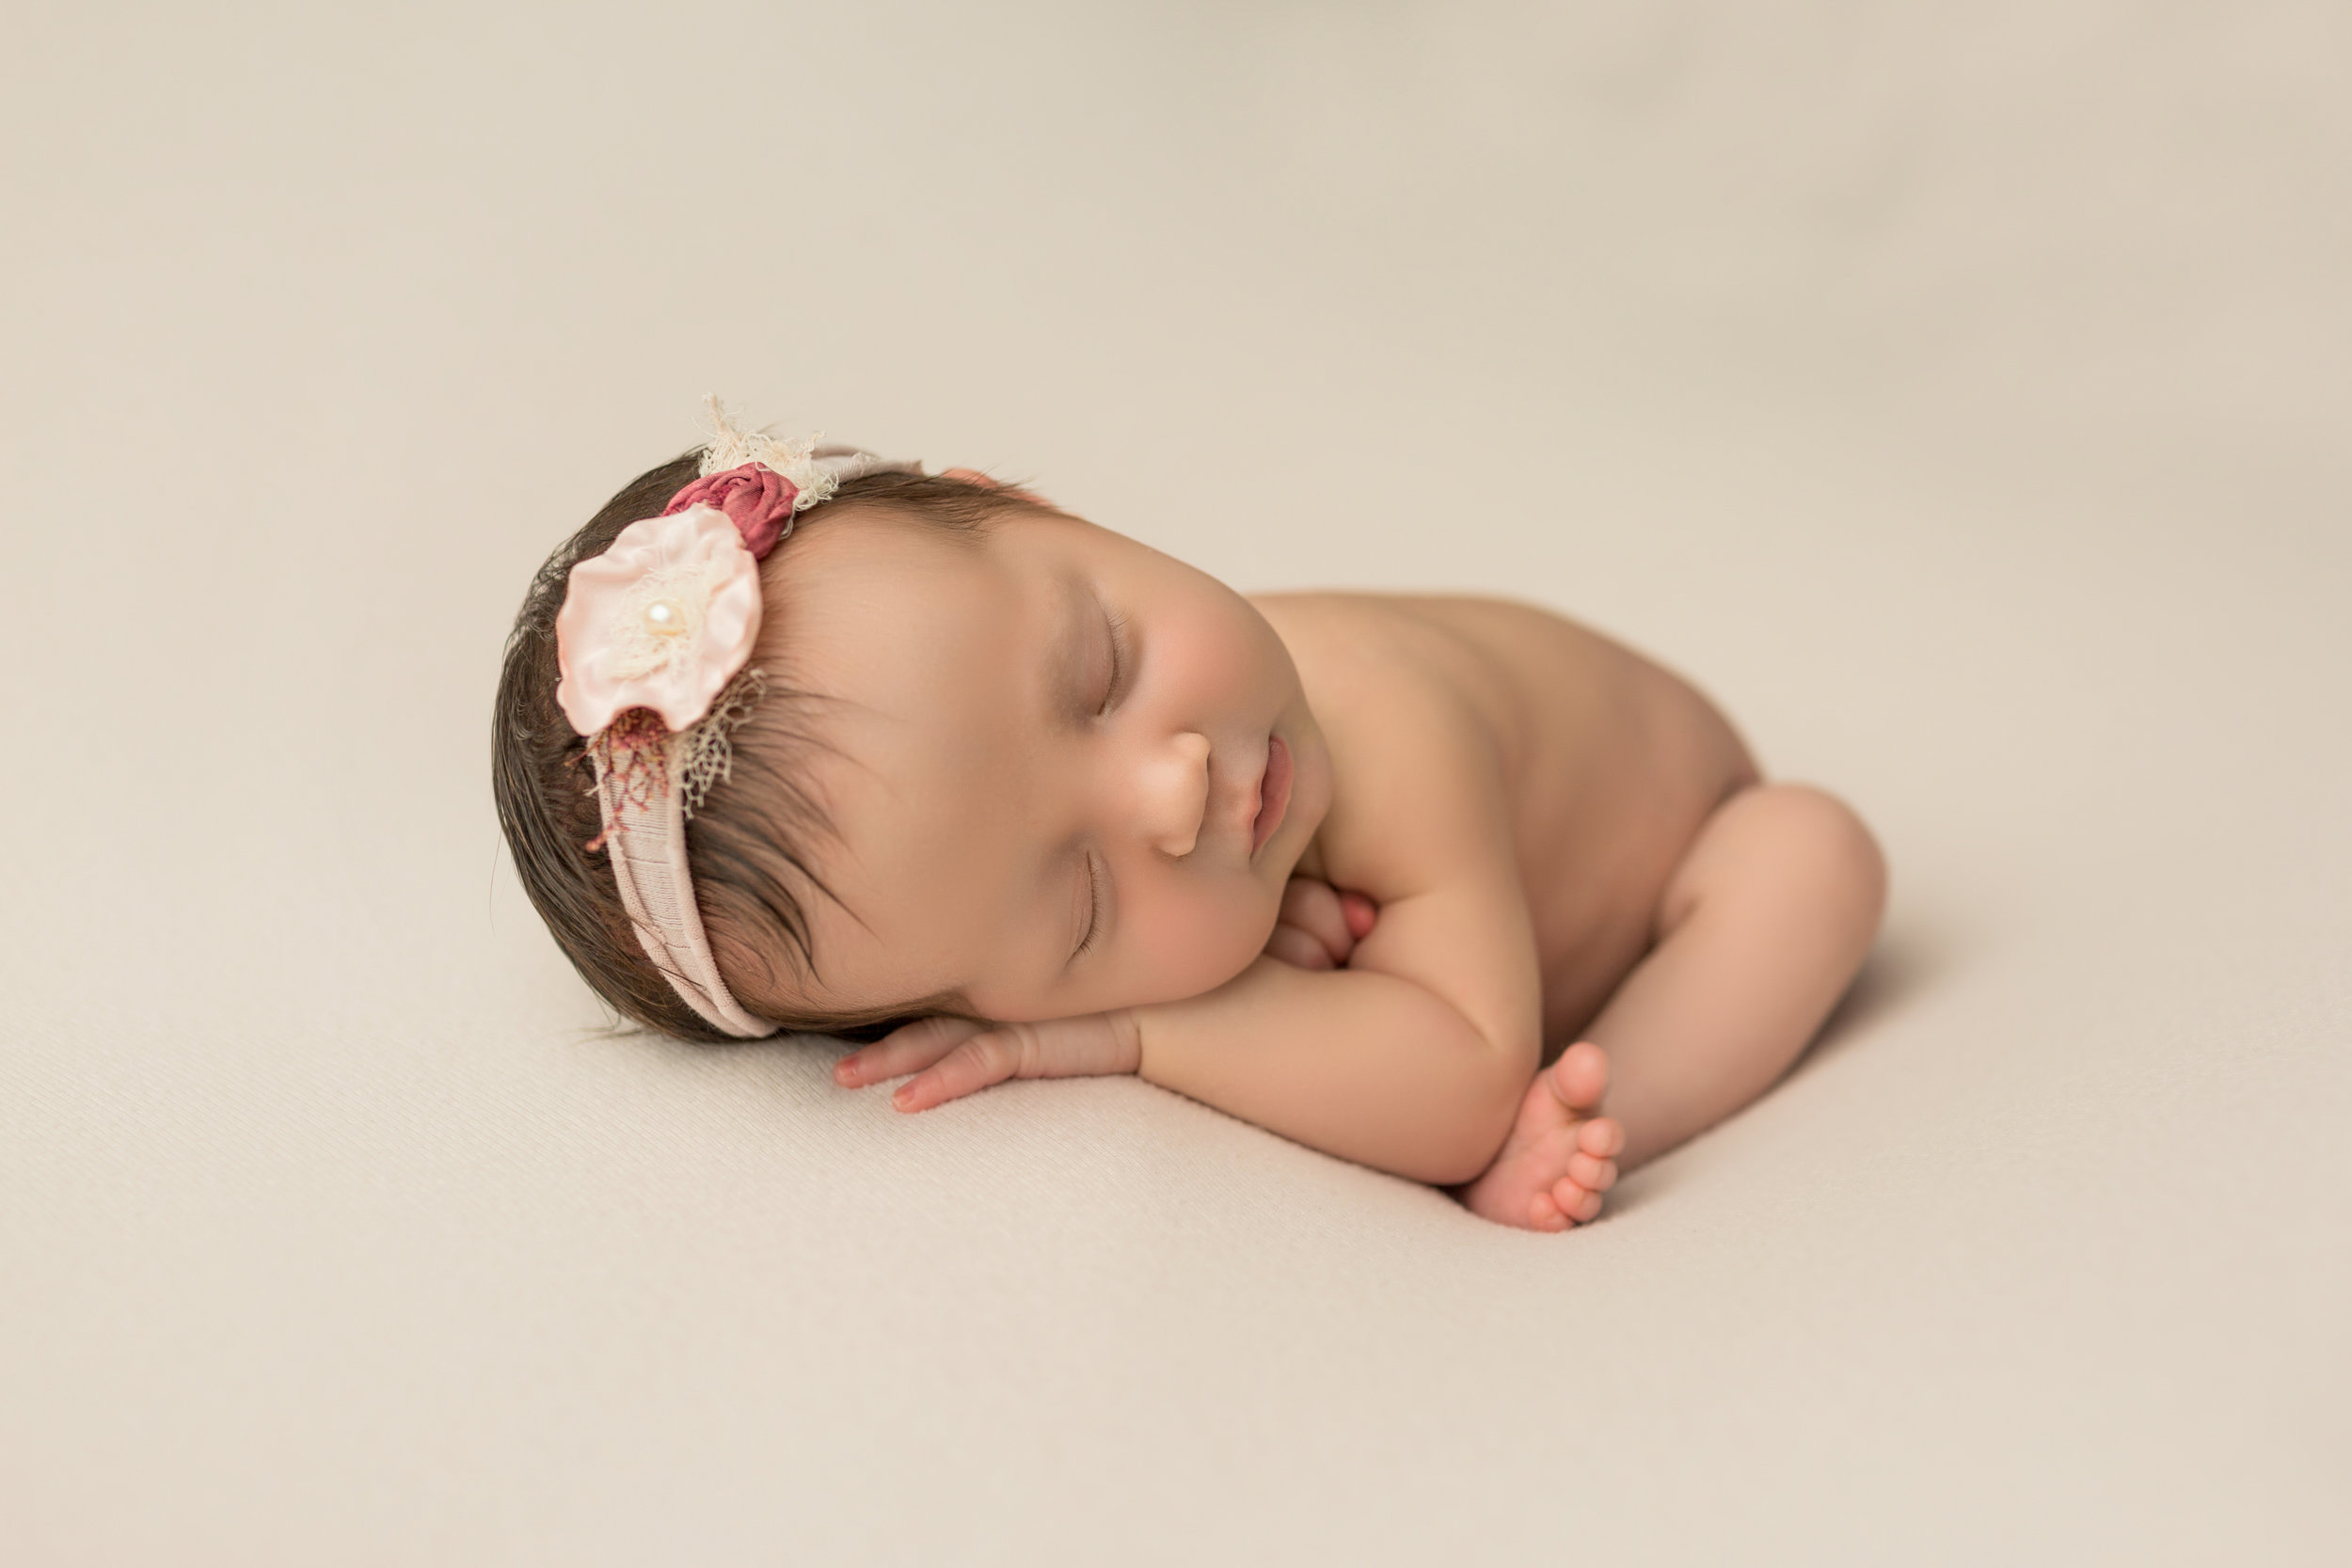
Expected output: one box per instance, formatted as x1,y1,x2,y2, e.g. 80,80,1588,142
555,400,922,1039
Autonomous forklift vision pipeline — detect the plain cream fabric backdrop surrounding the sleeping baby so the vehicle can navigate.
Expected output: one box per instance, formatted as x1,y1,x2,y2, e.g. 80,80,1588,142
0,0,2352,1563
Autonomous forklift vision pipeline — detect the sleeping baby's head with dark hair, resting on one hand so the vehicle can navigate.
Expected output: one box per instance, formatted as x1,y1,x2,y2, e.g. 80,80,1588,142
494,422,1329,1039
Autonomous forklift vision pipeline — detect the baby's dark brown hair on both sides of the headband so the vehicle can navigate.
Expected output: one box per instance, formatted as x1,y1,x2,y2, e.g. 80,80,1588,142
492,451,1042,1041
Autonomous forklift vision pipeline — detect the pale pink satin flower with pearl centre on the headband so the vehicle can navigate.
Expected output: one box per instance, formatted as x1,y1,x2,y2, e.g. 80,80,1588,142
555,510,762,736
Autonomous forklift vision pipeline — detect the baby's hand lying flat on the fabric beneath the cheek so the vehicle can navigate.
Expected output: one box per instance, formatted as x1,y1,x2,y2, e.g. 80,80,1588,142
833,1011,1143,1110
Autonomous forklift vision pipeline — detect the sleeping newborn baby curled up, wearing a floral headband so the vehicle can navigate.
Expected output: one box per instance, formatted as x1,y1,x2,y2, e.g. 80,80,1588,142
497,419,1886,1229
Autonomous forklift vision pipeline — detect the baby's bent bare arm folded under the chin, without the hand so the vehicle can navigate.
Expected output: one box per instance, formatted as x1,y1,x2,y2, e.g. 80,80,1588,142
1120,658,1543,1185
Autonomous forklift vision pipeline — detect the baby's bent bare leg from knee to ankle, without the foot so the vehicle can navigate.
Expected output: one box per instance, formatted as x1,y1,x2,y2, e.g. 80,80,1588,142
1585,785,1886,1168
